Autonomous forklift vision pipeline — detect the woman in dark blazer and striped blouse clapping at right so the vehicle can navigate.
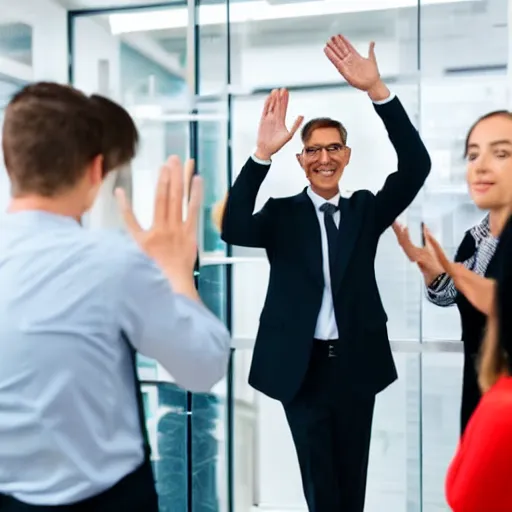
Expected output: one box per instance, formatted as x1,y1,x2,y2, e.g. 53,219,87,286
393,111,512,433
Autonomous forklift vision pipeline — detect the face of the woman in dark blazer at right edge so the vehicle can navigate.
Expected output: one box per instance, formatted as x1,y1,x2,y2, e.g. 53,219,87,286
467,115,512,210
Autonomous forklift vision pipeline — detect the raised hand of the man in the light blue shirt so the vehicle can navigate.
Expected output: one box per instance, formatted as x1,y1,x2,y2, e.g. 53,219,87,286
116,156,202,299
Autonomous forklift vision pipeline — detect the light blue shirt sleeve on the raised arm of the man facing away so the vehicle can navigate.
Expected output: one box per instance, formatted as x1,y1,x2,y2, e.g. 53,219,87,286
119,239,231,392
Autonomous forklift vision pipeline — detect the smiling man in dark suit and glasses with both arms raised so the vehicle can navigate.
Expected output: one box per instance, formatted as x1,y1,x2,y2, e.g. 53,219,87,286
222,36,430,512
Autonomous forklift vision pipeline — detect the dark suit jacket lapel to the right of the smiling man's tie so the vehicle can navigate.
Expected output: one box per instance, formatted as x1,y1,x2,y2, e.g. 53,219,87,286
331,198,363,294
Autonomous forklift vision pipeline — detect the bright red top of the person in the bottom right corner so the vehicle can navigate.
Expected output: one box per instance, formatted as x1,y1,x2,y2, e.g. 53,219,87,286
446,390,512,512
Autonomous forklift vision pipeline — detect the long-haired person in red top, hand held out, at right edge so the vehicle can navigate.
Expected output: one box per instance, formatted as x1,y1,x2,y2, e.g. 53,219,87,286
427,210,512,512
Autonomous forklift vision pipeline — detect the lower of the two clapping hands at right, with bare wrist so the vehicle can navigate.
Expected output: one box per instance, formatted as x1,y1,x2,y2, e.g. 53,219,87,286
425,228,496,315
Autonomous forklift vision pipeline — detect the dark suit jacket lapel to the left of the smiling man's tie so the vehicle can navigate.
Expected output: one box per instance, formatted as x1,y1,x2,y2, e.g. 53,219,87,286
296,190,324,288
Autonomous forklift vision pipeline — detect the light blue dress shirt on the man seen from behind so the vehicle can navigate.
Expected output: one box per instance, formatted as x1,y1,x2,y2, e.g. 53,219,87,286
0,211,230,505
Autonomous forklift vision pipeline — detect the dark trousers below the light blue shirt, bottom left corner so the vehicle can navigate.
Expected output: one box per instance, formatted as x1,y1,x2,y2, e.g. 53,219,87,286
0,461,158,512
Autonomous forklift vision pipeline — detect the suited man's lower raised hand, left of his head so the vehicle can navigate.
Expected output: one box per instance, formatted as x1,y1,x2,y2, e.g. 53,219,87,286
255,89,304,160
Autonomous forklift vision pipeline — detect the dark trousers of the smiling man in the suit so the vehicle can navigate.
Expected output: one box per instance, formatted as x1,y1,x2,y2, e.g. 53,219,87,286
284,340,375,512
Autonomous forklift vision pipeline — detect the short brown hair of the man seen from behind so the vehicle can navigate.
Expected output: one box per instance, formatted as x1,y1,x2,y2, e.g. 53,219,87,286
2,82,138,197
